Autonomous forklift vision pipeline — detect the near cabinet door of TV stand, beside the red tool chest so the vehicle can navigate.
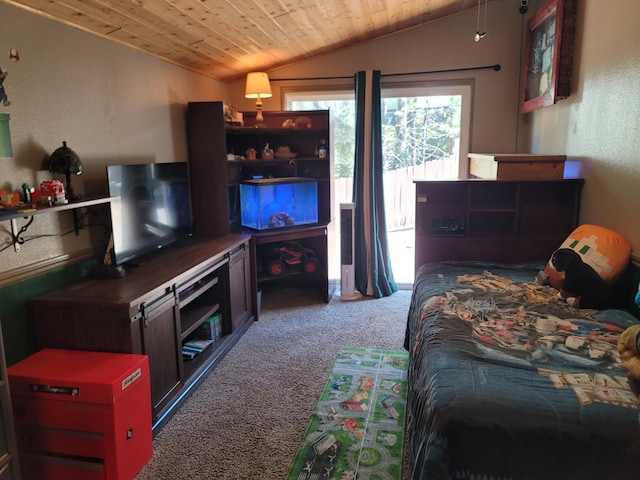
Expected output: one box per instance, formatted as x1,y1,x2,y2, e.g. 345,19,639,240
140,296,183,420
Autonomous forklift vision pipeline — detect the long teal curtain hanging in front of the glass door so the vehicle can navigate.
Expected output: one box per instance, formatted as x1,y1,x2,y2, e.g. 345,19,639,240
353,70,398,298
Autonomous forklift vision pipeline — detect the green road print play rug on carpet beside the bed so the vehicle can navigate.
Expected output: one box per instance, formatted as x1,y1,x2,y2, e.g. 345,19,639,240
286,347,409,480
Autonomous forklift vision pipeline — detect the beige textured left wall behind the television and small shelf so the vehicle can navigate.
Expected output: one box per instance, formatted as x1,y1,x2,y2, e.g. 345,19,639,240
0,3,228,282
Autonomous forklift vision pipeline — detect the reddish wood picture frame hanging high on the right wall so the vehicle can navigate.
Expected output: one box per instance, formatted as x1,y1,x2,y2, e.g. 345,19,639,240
520,0,576,113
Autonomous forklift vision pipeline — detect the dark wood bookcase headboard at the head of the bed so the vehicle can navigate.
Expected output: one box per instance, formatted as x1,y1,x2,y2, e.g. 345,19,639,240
415,179,584,269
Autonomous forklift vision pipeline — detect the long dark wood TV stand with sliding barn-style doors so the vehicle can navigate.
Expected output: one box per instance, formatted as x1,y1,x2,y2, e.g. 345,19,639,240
30,234,257,433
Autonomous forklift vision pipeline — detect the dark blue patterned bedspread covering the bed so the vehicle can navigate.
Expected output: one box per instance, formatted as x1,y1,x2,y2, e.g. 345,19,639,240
405,263,640,480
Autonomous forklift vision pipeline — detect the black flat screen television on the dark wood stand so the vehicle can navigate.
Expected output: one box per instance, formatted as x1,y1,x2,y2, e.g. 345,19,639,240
107,162,193,265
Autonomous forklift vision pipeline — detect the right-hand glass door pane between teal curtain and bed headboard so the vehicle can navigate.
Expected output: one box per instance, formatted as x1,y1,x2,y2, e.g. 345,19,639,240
382,86,471,288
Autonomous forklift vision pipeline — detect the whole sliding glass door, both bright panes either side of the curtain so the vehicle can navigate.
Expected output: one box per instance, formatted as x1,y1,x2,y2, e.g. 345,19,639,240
284,83,471,288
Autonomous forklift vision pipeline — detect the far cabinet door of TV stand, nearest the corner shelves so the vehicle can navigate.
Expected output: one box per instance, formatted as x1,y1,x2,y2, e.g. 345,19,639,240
229,244,251,330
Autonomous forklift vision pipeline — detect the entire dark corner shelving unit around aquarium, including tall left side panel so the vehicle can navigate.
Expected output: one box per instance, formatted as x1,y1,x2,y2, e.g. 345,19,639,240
187,102,331,304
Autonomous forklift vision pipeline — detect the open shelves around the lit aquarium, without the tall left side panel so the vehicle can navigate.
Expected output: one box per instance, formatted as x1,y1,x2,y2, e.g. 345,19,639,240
231,110,331,302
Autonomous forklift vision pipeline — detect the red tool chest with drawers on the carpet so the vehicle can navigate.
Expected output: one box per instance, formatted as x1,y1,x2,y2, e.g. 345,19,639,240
8,349,153,480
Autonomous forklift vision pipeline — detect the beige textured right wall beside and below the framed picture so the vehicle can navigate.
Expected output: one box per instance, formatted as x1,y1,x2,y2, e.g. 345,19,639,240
528,0,640,254
